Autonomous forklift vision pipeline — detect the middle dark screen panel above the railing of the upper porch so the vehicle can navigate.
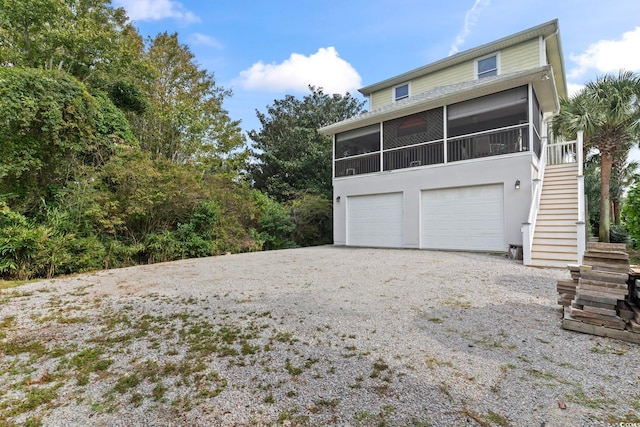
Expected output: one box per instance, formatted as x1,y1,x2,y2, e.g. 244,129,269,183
382,108,444,150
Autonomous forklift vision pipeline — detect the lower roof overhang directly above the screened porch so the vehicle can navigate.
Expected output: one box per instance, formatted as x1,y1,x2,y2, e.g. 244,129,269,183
319,65,560,135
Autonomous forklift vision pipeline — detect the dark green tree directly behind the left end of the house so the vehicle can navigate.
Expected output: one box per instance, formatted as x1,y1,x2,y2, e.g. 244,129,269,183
249,86,364,202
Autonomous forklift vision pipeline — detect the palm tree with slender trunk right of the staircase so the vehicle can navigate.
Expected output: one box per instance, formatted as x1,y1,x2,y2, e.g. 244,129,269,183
553,71,640,242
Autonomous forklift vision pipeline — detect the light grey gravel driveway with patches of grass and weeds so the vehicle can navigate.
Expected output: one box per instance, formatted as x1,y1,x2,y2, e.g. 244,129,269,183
0,246,640,426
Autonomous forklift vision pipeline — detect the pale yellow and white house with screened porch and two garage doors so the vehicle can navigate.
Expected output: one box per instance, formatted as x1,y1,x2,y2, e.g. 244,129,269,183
320,20,584,265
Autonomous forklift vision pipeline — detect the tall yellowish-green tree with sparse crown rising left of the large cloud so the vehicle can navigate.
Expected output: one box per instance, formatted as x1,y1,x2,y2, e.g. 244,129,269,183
130,32,247,172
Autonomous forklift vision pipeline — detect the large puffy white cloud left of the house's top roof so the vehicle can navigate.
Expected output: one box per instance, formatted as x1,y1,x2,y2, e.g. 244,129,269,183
235,47,362,93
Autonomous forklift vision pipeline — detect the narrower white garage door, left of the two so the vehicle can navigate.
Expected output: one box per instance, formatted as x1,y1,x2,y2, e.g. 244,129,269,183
347,193,403,248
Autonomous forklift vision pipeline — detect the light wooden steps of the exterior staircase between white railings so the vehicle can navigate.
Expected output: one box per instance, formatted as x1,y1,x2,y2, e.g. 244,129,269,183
531,162,579,267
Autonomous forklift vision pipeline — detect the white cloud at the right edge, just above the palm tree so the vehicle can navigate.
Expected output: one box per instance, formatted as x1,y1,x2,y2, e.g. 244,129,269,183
568,27,640,78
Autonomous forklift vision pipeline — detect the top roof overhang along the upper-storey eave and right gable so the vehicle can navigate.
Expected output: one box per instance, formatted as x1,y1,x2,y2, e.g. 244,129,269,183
358,19,564,96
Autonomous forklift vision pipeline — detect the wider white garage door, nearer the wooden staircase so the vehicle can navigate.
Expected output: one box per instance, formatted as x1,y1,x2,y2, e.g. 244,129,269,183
421,184,505,251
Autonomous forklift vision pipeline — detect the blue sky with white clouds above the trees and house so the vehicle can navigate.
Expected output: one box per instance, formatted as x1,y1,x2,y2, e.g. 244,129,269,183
112,0,640,137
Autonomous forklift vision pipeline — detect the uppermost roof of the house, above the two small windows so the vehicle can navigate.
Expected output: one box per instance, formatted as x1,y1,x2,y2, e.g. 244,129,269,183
358,19,567,97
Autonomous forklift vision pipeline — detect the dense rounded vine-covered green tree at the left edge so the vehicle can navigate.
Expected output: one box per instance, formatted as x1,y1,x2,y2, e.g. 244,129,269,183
0,67,135,207
